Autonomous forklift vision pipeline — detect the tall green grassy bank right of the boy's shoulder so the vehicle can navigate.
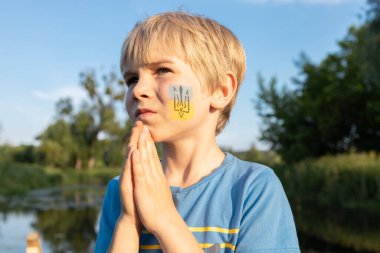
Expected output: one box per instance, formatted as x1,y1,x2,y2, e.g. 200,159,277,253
276,152,380,211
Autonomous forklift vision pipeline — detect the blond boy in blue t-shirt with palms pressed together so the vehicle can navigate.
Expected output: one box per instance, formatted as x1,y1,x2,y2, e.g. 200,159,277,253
95,12,299,253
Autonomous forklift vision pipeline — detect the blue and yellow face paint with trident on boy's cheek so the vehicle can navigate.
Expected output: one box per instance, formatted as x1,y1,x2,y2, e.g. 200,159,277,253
169,85,195,120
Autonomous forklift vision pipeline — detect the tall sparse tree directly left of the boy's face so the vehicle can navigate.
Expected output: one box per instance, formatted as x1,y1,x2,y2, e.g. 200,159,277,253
73,71,124,168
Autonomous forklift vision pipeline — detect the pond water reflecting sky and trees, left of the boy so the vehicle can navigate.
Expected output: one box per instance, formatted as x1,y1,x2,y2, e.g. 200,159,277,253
0,186,105,253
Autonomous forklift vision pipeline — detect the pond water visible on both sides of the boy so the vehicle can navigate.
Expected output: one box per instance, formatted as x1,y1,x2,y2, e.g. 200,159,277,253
0,185,380,253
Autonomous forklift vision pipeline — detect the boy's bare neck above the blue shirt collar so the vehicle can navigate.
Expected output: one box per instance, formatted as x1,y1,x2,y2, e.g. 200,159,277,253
162,137,225,188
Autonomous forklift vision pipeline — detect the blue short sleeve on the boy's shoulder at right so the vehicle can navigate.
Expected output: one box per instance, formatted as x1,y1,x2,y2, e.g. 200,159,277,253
235,169,300,253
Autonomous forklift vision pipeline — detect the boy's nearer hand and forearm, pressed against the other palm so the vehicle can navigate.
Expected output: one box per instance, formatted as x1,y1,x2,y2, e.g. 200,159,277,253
128,126,203,253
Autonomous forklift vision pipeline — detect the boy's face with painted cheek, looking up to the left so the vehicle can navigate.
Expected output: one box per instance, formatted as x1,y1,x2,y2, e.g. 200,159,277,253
124,55,211,142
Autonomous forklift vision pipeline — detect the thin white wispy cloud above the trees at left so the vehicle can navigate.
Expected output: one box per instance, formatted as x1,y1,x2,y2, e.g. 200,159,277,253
33,85,86,104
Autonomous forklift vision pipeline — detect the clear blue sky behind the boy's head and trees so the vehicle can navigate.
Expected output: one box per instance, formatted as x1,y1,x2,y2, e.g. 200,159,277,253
0,0,366,150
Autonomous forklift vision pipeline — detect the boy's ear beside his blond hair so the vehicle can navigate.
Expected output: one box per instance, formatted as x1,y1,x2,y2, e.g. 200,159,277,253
211,72,237,110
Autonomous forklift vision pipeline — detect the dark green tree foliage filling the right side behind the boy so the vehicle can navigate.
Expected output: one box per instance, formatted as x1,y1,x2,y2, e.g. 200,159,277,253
256,1,380,161
